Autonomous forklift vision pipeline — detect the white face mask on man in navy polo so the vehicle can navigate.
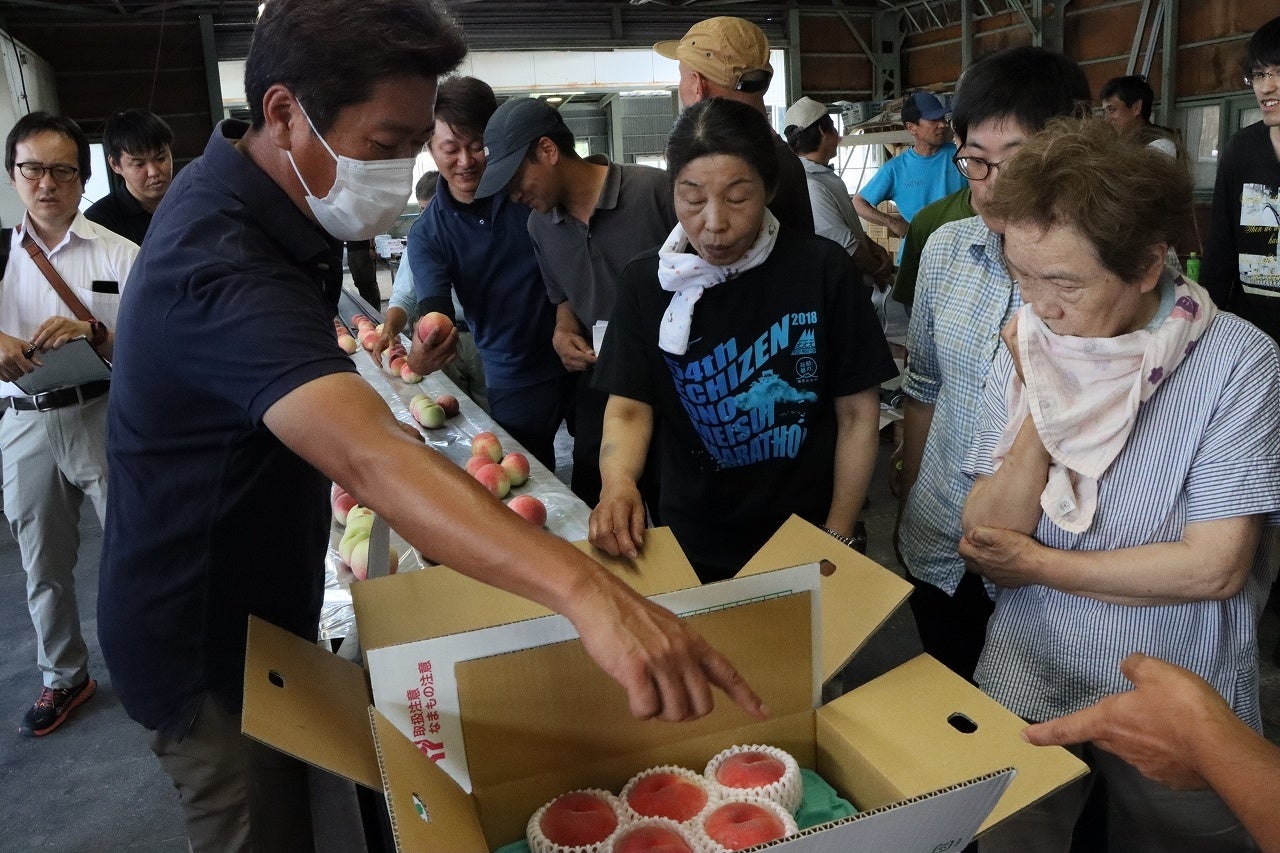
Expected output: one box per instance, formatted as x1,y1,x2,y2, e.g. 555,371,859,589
285,101,413,241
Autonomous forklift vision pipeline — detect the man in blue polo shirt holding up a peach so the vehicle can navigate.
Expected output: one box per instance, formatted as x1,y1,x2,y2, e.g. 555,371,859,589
407,77,573,470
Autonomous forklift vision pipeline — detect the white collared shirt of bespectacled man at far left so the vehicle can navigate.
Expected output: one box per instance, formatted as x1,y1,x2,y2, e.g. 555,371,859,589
0,211,138,397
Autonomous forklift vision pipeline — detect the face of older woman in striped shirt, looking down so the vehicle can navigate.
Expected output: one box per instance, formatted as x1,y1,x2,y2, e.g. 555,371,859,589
1005,223,1164,338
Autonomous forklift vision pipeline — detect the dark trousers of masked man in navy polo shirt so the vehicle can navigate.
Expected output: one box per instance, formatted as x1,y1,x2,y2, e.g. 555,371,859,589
151,693,315,853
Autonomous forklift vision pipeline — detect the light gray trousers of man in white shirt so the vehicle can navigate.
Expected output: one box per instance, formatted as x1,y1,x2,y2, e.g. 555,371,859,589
0,394,106,688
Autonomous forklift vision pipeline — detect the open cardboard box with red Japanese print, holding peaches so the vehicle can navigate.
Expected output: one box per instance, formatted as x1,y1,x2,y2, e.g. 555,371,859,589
243,519,1085,853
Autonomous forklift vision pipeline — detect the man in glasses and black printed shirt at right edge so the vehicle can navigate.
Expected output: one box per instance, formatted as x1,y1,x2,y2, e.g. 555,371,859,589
1201,18,1280,341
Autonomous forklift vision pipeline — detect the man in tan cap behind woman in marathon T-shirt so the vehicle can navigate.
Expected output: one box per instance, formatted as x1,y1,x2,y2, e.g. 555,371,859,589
653,17,813,232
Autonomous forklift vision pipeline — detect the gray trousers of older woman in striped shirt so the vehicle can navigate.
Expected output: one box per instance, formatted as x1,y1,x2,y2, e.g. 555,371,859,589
978,744,1258,853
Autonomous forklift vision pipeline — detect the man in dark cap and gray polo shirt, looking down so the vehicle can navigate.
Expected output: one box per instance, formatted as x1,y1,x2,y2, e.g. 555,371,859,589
476,97,676,510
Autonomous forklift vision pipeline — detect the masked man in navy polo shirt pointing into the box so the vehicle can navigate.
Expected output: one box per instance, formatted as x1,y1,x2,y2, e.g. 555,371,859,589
99,0,763,850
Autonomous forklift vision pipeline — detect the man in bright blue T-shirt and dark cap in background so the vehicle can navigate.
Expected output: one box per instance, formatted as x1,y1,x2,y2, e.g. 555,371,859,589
854,92,969,237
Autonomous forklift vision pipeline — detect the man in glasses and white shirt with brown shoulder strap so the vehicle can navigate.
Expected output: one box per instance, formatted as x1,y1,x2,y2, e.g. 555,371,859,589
0,113,138,738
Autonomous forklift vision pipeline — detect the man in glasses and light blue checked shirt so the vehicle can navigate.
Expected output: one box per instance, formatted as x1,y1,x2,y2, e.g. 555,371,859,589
899,47,1089,680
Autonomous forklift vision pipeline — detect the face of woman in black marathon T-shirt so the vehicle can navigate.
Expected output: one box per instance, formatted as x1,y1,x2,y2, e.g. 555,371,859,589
676,154,768,266
